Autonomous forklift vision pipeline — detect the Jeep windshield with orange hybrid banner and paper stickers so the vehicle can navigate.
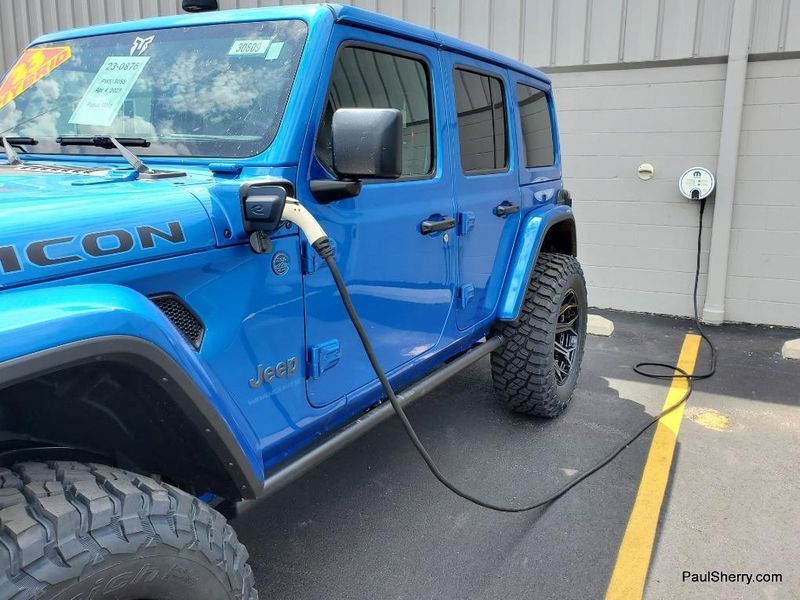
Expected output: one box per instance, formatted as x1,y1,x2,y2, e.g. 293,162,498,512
0,20,307,158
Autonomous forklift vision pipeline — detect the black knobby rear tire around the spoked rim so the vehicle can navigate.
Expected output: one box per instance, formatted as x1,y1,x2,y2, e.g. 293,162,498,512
491,252,587,417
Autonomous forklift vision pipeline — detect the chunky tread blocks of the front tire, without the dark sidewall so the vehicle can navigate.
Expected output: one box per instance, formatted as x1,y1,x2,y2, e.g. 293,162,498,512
0,461,258,600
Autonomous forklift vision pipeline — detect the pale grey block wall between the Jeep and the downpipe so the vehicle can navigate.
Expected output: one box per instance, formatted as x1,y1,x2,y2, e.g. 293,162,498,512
553,64,725,315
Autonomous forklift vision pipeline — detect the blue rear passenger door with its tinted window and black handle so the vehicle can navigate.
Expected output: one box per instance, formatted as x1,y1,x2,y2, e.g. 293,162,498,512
445,58,520,330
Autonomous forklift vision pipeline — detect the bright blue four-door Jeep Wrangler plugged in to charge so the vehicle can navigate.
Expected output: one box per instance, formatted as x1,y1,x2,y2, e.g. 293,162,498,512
0,5,586,600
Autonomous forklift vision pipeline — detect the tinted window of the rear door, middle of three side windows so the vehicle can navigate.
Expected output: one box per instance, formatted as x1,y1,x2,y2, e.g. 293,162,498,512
453,69,508,173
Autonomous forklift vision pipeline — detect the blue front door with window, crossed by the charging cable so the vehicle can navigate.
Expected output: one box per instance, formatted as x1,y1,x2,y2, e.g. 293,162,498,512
298,30,455,406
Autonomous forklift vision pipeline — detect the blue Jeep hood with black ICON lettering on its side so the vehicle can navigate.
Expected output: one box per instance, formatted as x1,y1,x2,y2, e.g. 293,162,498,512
0,163,215,289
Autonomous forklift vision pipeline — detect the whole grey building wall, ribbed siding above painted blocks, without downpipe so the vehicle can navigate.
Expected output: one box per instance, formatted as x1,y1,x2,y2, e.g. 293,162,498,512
0,0,800,326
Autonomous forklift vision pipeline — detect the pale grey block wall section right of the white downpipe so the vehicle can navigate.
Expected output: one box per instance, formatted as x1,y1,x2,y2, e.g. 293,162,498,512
725,60,800,326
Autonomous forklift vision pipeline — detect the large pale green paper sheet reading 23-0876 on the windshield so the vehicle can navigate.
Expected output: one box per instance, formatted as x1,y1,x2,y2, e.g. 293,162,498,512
69,56,150,127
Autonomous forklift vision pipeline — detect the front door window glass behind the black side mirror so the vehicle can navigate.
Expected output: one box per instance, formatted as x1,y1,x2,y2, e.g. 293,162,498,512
316,46,433,177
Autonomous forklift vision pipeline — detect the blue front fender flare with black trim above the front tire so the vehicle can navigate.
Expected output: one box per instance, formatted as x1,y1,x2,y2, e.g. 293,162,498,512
0,284,264,497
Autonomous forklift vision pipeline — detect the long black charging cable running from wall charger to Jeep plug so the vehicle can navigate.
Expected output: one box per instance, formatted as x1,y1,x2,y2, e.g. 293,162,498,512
312,199,717,513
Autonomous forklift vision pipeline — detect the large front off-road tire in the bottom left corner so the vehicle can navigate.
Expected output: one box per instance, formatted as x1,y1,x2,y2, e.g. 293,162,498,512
0,462,258,600
